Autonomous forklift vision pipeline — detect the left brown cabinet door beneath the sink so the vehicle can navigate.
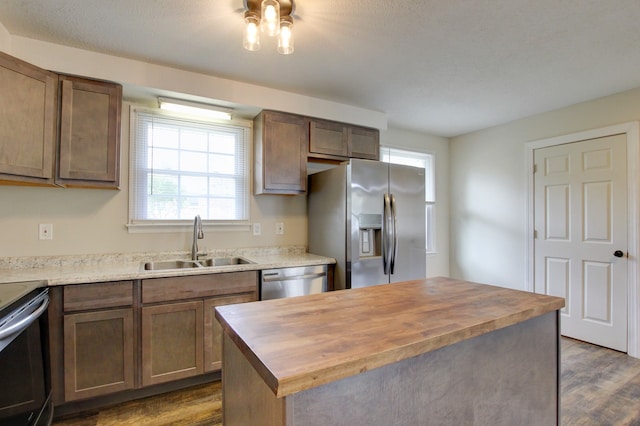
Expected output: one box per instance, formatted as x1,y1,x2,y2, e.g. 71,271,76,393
141,301,204,386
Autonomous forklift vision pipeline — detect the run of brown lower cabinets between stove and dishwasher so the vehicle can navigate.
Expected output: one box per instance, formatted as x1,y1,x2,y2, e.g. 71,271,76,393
49,271,258,405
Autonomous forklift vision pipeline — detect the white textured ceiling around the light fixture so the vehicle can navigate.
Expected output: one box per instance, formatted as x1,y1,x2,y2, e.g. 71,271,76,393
0,0,640,136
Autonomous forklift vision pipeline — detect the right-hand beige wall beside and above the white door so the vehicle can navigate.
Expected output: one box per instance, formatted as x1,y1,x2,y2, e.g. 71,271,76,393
450,89,640,289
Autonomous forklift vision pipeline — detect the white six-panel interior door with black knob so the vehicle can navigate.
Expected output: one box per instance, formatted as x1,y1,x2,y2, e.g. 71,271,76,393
534,135,628,352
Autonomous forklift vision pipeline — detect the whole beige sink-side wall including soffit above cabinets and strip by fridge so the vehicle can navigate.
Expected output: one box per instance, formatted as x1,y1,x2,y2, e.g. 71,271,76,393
0,35,448,260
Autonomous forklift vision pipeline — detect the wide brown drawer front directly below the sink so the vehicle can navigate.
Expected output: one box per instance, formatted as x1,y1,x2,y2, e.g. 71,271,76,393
142,271,258,303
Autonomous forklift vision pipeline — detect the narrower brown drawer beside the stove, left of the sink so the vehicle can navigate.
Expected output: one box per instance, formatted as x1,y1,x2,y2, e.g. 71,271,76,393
63,281,133,312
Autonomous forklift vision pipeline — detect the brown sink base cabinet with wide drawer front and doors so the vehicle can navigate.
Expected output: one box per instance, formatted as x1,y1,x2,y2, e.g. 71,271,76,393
141,271,258,386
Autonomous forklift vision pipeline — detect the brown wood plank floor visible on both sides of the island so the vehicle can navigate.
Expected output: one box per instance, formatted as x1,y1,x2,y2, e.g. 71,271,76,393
53,338,640,426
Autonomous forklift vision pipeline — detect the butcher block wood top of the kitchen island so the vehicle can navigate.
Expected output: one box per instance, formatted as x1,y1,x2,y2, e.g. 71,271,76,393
215,278,564,397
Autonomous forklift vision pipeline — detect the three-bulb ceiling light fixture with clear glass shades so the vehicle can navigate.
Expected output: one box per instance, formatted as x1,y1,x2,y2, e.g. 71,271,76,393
242,0,295,55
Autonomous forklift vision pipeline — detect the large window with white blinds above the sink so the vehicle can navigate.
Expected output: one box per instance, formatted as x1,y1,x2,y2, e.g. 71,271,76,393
129,109,251,225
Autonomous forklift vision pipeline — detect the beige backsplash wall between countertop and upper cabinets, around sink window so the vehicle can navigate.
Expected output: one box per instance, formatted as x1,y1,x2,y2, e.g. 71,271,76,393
0,99,307,257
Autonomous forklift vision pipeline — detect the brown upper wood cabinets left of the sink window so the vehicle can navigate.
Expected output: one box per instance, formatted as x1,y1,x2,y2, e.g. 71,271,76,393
0,52,122,188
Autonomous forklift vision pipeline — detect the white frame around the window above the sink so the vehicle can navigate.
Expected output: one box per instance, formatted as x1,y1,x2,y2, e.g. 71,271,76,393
126,105,253,233
